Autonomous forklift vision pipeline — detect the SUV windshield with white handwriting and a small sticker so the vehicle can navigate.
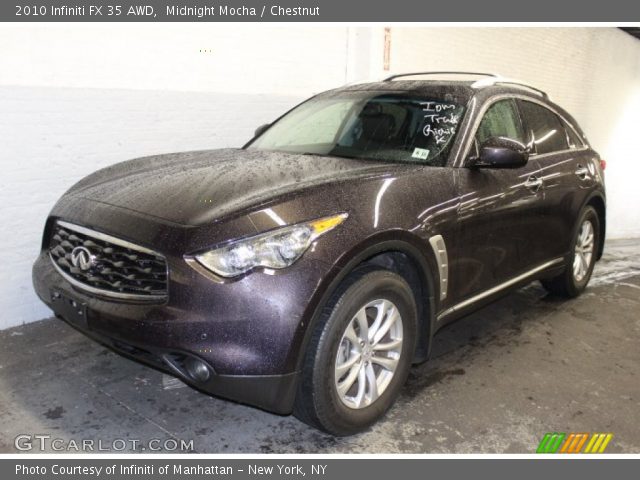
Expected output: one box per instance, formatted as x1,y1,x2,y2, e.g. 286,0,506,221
247,92,464,166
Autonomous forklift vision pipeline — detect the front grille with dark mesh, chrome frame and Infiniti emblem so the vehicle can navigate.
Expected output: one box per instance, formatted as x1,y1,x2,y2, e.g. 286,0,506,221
49,221,167,300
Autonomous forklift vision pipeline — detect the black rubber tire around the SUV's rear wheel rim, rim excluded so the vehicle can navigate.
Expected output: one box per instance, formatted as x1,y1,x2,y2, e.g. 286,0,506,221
541,206,600,298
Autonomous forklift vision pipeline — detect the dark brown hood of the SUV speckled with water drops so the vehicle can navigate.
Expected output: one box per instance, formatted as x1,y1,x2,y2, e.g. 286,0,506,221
67,149,393,225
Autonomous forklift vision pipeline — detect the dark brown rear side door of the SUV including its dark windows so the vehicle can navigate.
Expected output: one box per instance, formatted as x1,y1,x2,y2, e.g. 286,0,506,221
518,100,596,262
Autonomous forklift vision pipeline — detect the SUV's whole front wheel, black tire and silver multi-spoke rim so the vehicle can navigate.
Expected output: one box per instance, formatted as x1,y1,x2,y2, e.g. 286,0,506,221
294,269,418,436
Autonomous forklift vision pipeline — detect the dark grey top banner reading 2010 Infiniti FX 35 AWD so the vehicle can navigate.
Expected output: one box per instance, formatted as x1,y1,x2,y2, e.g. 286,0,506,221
0,0,640,21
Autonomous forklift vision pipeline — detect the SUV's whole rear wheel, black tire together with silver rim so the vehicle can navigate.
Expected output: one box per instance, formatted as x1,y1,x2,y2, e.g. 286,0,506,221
541,206,600,298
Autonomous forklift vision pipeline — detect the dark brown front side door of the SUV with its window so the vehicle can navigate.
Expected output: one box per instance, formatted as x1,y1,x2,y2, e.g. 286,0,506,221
450,98,543,299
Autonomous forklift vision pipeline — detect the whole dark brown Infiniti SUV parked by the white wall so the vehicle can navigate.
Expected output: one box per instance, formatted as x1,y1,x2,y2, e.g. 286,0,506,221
33,72,605,435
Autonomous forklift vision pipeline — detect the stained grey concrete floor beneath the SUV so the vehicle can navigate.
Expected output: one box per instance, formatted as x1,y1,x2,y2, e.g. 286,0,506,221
0,241,640,453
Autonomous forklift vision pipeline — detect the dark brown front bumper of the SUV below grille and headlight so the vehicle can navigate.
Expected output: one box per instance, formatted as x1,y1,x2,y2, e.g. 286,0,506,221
33,227,327,414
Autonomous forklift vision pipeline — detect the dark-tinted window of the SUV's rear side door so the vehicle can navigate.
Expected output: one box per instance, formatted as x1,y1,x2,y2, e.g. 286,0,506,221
520,101,569,154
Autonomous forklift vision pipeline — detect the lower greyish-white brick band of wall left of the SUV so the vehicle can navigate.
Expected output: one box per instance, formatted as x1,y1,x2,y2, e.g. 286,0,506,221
0,87,302,328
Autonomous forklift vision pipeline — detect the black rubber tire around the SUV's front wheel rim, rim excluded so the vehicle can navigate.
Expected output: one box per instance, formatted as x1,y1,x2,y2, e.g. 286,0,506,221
294,268,418,436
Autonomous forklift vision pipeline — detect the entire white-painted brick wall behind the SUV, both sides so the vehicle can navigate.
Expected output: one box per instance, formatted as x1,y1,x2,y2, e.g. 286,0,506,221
0,24,640,328
